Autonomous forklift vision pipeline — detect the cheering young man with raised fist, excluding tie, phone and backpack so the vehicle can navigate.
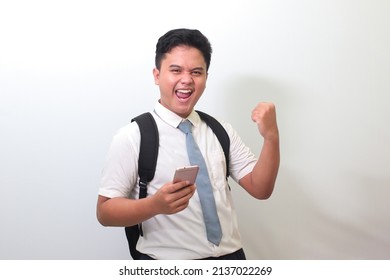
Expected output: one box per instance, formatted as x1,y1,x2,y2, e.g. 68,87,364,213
97,29,279,259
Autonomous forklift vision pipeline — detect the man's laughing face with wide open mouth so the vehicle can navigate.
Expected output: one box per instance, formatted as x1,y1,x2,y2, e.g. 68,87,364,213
153,46,207,118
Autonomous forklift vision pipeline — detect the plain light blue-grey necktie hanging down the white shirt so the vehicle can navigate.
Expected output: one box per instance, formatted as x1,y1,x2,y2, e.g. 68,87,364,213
179,120,222,246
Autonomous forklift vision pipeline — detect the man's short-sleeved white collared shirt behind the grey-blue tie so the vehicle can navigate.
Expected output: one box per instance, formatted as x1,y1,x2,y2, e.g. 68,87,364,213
99,103,257,259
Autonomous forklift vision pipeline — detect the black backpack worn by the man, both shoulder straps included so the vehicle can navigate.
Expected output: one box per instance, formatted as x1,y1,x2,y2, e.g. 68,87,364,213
125,111,230,260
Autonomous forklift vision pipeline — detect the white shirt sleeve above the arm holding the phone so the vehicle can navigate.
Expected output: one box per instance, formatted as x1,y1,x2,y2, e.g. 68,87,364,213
99,123,140,198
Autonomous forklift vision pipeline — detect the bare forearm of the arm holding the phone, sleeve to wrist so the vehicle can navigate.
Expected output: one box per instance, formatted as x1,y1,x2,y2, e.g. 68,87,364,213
97,196,156,227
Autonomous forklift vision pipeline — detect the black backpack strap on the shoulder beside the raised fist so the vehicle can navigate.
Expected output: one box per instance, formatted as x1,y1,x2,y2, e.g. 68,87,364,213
196,110,230,178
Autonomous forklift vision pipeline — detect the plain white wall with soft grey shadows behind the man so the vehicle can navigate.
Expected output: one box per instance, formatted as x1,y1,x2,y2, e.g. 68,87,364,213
0,0,390,259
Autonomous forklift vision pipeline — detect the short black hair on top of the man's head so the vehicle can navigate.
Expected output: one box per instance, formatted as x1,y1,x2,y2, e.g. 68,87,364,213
155,28,212,70
